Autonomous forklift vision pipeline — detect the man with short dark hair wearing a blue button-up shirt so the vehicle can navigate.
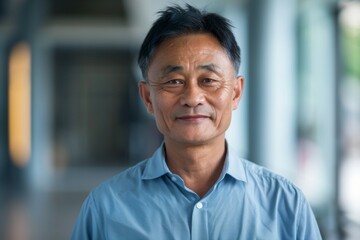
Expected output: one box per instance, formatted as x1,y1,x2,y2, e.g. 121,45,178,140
72,5,321,240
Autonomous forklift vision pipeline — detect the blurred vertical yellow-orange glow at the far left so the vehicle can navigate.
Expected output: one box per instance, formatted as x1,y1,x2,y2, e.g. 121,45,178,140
9,42,31,167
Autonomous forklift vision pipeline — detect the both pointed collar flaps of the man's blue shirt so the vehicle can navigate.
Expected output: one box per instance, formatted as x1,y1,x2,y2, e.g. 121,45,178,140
142,143,246,182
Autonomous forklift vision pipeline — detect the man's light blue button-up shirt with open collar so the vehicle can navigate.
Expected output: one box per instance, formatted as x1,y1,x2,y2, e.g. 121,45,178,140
71,143,321,240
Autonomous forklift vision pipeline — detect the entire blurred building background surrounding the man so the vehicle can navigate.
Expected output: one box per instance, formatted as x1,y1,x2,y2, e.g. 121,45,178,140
0,0,360,240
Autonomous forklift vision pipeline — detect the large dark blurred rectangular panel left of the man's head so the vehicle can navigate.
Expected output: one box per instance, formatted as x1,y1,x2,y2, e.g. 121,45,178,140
54,48,160,166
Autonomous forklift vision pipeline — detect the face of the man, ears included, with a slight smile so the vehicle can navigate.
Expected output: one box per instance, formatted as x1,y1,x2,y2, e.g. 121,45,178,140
139,34,243,146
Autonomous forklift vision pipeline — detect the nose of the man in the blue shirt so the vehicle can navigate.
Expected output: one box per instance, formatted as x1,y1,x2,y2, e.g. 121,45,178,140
180,81,205,108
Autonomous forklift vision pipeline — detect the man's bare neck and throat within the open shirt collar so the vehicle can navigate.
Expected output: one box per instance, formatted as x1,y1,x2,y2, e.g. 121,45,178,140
165,139,226,197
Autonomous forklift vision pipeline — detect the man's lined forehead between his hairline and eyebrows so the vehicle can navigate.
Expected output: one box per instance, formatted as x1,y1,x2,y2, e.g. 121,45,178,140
149,33,233,74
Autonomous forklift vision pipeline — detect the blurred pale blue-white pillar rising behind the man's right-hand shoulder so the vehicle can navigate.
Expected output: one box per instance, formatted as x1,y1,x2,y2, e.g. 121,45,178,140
248,0,296,178
